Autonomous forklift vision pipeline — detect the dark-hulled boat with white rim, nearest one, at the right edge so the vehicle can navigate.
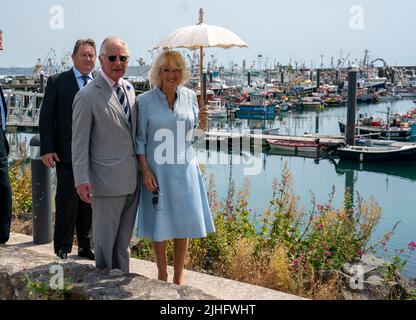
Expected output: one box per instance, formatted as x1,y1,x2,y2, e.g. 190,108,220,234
337,144,416,162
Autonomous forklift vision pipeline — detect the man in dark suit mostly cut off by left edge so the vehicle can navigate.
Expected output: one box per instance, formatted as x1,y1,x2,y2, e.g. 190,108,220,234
0,30,12,244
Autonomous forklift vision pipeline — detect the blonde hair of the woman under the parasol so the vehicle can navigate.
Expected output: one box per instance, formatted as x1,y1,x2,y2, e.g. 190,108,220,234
149,50,190,87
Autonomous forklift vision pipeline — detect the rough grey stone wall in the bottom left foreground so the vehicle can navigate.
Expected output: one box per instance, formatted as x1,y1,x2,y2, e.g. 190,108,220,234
0,246,216,300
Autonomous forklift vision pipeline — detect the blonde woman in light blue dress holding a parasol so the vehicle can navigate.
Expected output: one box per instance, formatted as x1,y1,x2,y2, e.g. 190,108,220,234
136,51,215,285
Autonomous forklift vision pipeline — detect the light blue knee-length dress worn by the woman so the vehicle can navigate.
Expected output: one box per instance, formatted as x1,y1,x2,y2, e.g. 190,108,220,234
136,87,215,242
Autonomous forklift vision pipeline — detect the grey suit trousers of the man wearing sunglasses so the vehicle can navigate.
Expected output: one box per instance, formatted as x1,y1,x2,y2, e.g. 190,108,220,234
92,187,139,273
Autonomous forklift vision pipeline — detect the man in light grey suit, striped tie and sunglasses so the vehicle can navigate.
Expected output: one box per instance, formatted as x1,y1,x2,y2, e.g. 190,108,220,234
72,37,139,273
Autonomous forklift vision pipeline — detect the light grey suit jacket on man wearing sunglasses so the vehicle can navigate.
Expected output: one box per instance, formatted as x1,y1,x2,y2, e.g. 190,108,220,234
72,74,138,196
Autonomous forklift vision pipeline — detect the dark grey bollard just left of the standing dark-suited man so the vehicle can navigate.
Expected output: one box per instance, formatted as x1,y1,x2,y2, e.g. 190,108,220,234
30,135,52,244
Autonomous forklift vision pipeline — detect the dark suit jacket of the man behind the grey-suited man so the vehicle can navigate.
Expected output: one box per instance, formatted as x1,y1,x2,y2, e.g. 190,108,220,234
39,69,84,163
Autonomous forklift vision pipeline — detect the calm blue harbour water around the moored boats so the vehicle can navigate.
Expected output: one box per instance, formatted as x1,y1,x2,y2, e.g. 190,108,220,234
9,100,416,277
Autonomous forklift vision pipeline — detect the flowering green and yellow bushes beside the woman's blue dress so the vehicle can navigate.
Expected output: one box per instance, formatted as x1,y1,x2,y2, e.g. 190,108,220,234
133,166,388,299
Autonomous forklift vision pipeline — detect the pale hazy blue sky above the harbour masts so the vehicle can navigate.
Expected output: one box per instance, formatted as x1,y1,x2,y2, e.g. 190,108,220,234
0,0,416,67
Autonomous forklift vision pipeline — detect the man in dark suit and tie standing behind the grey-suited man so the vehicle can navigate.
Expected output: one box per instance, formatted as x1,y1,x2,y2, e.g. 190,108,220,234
39,39,96,260
